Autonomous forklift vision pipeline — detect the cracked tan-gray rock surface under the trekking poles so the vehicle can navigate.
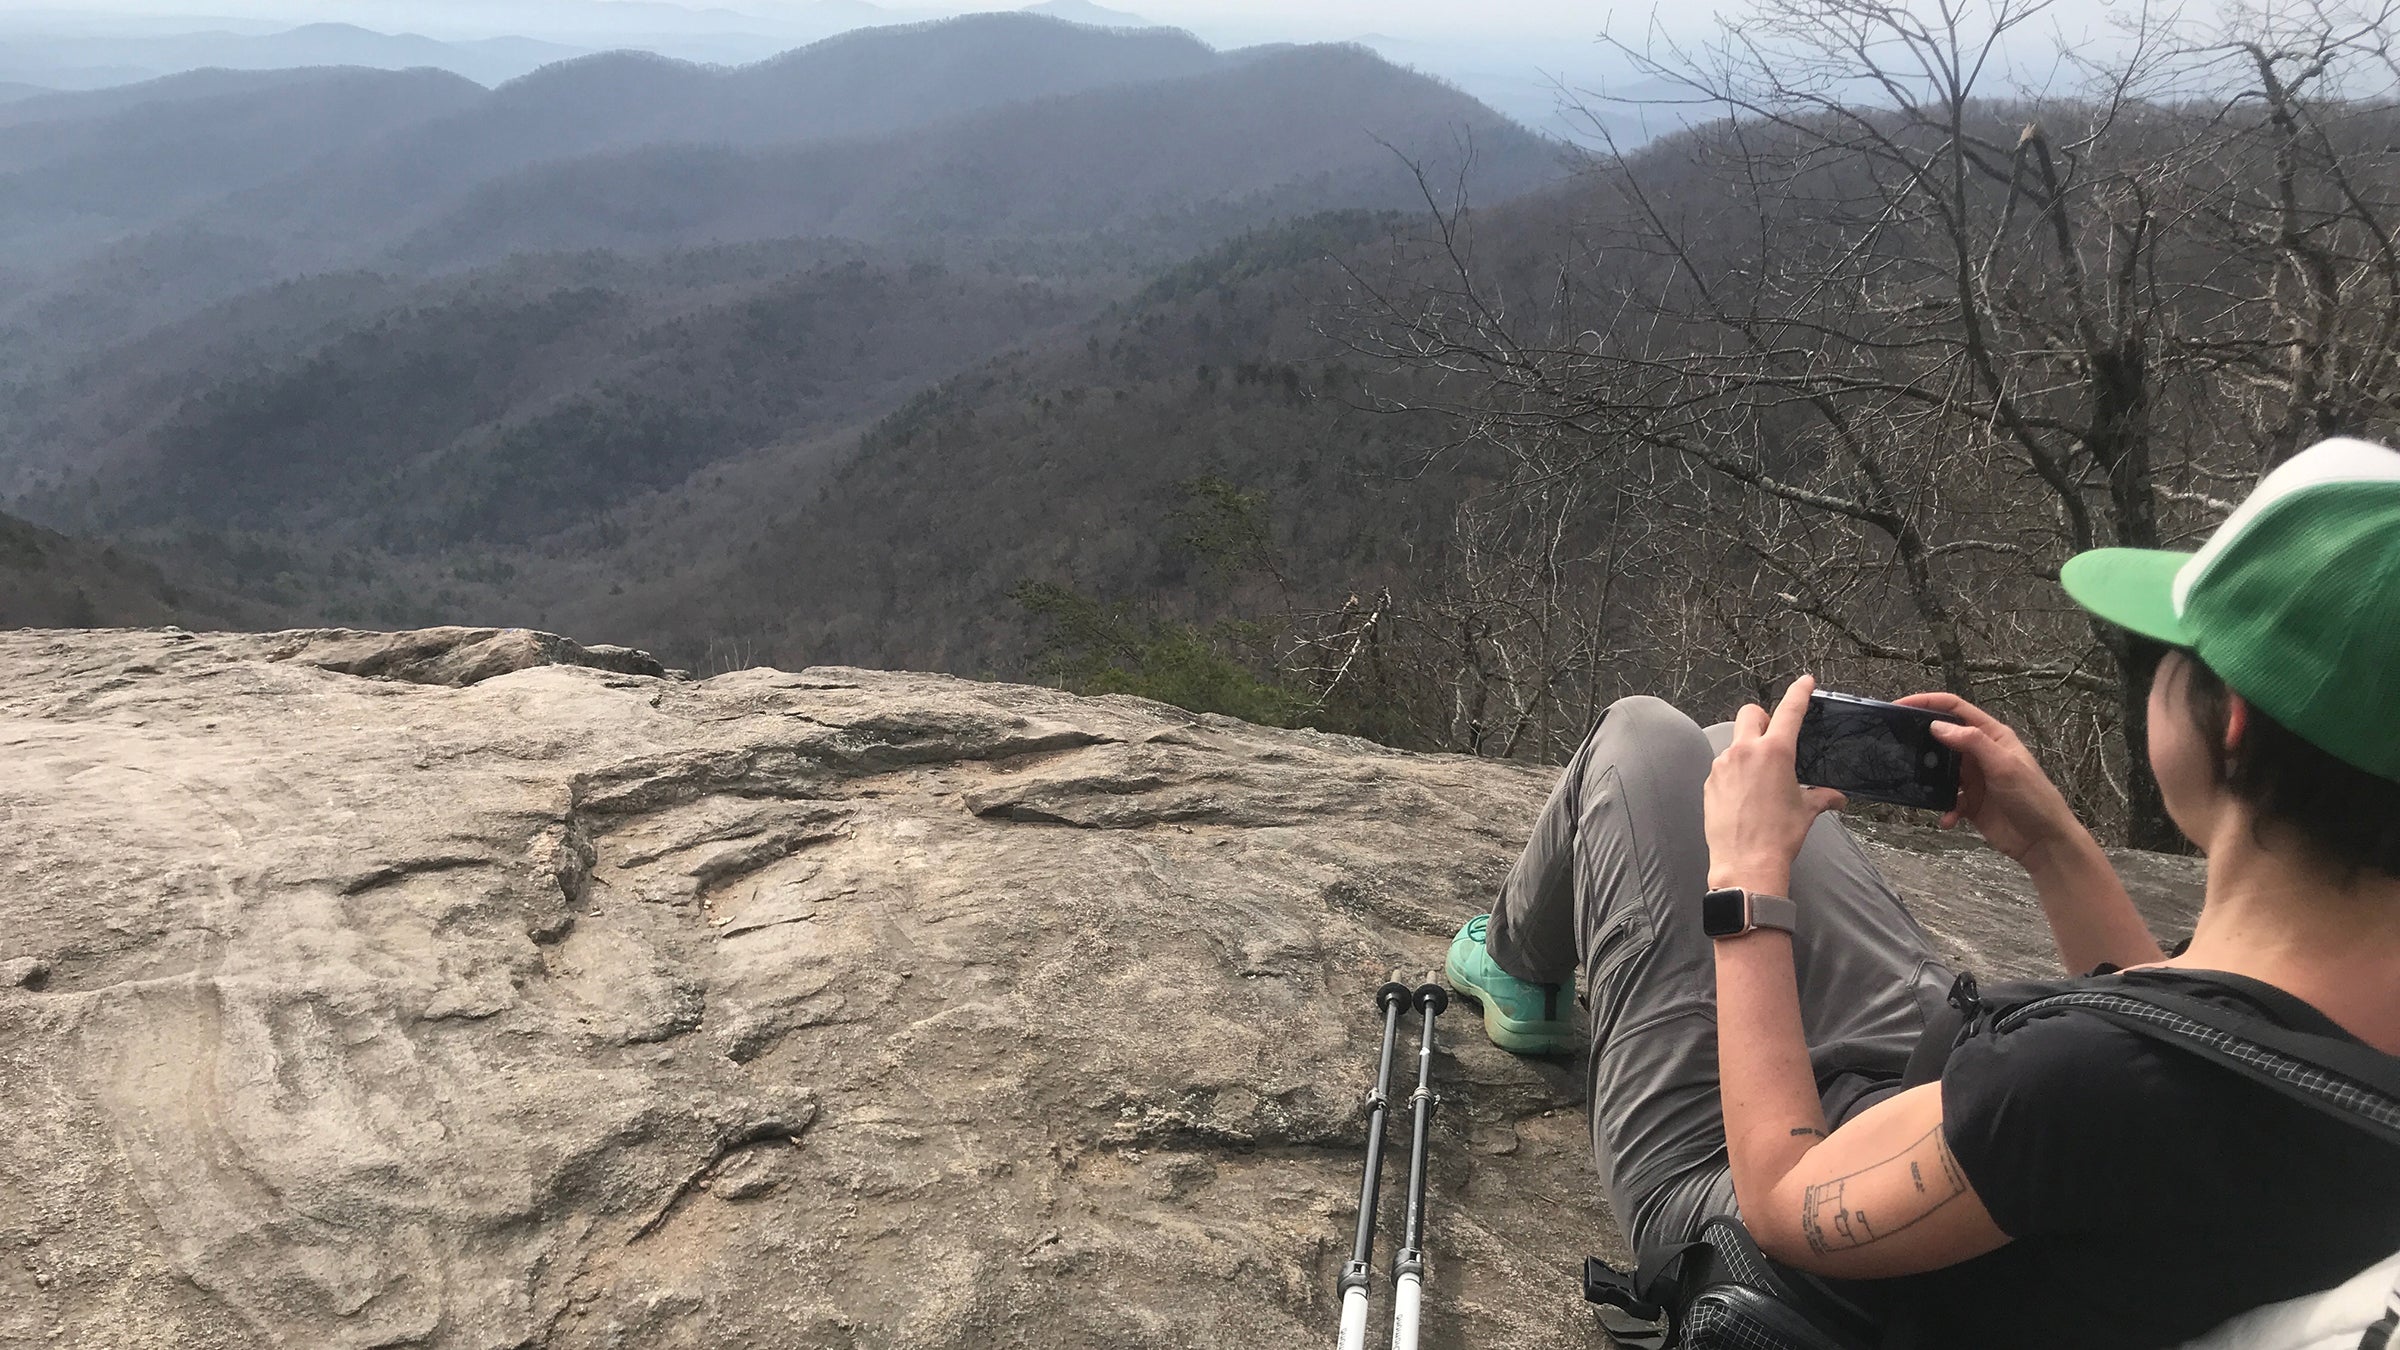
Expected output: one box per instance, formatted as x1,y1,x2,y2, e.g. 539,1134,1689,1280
0,629,2198,1350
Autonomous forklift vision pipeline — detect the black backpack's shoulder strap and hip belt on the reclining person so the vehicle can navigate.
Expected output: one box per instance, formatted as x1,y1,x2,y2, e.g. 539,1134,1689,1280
1584,975,2400,1350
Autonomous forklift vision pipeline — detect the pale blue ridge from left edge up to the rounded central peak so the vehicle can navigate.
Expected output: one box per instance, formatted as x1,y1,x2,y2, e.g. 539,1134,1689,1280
0,14,1226,333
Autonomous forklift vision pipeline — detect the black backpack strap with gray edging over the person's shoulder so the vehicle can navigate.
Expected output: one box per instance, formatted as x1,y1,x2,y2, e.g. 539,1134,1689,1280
1994,987,2400,1146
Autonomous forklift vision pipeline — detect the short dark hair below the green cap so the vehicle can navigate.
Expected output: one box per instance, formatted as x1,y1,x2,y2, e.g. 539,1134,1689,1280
2174,649,2400,879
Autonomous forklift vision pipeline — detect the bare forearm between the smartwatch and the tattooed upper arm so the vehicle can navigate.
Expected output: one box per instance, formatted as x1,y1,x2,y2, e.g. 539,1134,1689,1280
1716,912,1824,1213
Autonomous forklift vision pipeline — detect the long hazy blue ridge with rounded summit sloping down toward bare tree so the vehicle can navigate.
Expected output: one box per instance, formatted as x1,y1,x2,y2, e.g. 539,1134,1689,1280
398,46,1553,269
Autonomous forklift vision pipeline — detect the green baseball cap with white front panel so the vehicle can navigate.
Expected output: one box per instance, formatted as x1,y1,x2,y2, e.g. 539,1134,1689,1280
2059,437,2400,778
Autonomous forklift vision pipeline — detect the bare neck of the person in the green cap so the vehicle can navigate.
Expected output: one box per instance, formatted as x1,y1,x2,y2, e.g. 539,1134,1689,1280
2167,812,2400,1055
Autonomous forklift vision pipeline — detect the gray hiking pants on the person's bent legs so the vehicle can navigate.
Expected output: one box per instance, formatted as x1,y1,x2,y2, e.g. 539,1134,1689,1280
1486,697,1951,1252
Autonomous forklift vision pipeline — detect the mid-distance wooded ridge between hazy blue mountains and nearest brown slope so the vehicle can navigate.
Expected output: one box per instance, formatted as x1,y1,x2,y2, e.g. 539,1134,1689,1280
65,259,1092,535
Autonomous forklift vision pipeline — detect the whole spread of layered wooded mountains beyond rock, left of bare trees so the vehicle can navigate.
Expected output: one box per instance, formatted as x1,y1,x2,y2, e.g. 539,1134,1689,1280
0,14,1558,653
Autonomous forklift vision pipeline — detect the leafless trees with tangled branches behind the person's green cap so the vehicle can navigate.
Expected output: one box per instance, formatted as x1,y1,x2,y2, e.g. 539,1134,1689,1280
1351,0,2400,846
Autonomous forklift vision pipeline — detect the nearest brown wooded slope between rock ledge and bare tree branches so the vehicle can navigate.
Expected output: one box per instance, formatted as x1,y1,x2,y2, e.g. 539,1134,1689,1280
552,211,1459,677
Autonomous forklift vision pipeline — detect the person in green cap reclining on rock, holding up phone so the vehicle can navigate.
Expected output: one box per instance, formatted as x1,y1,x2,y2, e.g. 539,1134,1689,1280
1447,440,2400,1350
